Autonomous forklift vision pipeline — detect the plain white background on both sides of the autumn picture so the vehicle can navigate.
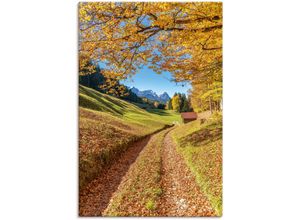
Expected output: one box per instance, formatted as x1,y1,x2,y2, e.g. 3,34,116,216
0,0,300,220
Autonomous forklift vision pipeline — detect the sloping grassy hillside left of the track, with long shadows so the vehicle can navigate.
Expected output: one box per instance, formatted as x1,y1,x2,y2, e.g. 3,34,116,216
79,86,181,191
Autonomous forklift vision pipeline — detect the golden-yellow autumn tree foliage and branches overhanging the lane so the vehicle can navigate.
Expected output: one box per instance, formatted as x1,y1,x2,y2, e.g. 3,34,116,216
79,2,223,109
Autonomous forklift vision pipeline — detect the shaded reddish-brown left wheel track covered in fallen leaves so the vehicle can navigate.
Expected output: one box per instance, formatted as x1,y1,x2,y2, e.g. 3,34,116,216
79,136,151,216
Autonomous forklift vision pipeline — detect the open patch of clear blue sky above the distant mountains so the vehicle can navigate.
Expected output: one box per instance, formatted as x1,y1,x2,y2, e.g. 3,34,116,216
121,66,191,97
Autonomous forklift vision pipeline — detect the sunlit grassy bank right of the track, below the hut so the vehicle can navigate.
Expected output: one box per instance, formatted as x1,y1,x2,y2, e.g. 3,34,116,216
171,112,222,216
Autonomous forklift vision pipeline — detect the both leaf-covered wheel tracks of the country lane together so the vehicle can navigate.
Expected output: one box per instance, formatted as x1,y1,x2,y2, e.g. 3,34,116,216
79,127,215,216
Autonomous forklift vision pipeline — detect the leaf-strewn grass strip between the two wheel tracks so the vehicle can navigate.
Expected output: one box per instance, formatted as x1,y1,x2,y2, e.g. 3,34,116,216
104,130,168,216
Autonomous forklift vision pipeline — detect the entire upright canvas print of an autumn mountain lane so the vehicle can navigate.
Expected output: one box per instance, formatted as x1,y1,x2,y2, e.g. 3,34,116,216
78,2,223,217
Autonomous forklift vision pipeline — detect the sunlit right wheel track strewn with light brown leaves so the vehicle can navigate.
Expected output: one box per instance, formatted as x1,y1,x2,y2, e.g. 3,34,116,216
160,133,214,216
